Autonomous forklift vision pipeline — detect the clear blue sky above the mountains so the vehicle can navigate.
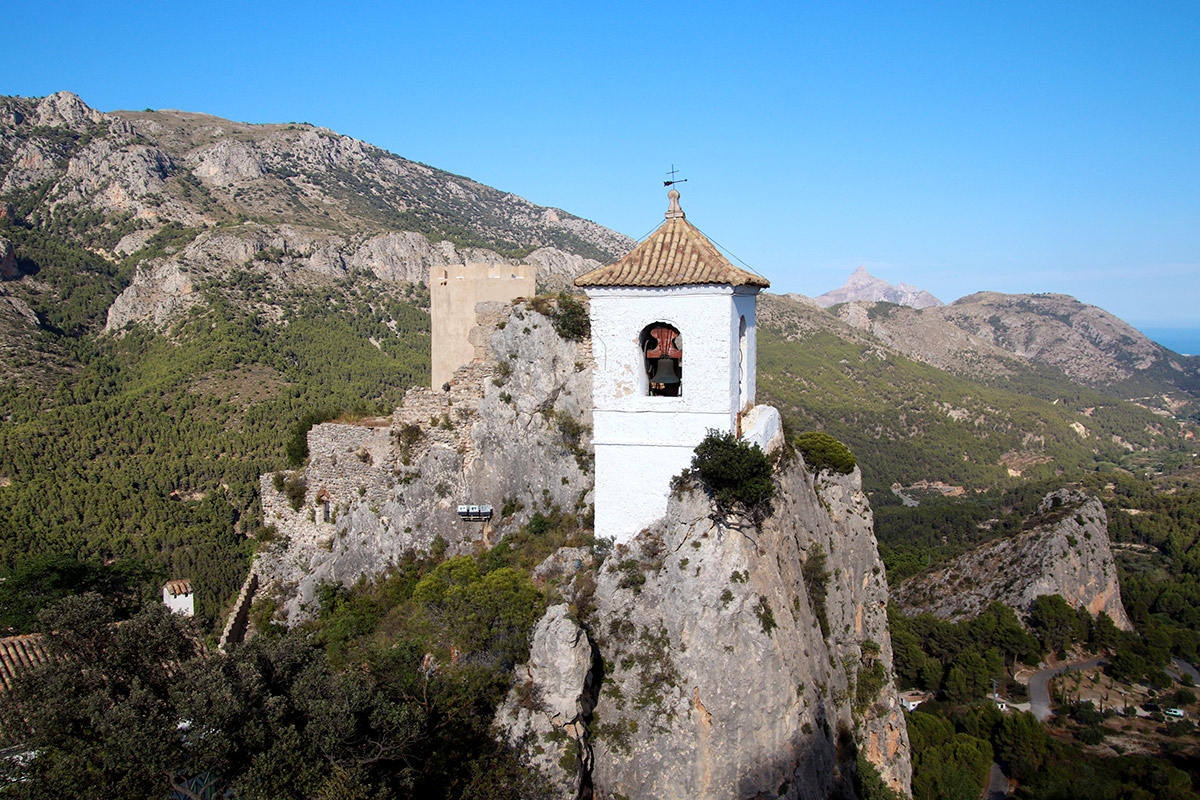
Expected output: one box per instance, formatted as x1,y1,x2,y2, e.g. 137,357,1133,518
0,0,1200,327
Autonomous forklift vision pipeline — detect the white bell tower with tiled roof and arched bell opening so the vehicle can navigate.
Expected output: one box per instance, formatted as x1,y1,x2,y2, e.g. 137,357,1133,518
575,190,778,542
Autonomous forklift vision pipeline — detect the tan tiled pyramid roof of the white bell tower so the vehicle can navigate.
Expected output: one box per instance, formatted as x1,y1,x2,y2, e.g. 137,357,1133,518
575,190,770,289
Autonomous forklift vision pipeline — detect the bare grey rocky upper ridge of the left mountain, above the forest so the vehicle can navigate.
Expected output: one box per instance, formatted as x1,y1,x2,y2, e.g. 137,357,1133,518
0,92,634,343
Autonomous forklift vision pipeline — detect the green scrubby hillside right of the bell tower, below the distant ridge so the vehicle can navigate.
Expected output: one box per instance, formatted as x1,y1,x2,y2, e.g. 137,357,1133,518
758,295,1200,501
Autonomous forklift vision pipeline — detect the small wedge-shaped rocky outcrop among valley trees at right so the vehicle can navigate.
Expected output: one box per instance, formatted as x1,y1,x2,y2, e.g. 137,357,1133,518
895,489,1133,631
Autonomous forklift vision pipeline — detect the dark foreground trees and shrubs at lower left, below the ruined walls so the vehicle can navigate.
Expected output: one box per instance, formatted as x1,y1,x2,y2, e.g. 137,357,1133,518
0,532,568,800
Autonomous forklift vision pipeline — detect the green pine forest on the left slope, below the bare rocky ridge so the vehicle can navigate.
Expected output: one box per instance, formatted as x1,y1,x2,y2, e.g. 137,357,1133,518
0,215,430,632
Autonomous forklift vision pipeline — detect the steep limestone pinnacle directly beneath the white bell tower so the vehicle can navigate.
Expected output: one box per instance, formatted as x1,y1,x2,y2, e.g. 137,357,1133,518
508,462,911,799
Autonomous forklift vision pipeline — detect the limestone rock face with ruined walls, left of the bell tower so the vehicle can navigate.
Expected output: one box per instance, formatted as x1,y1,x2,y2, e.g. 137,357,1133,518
253,303,592,621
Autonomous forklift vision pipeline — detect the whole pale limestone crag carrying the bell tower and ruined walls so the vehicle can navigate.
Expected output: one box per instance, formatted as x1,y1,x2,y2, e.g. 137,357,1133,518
253,298,911,798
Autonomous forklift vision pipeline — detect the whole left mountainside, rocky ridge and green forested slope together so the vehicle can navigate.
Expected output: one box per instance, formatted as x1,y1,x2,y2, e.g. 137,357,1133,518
0,92,628,631
